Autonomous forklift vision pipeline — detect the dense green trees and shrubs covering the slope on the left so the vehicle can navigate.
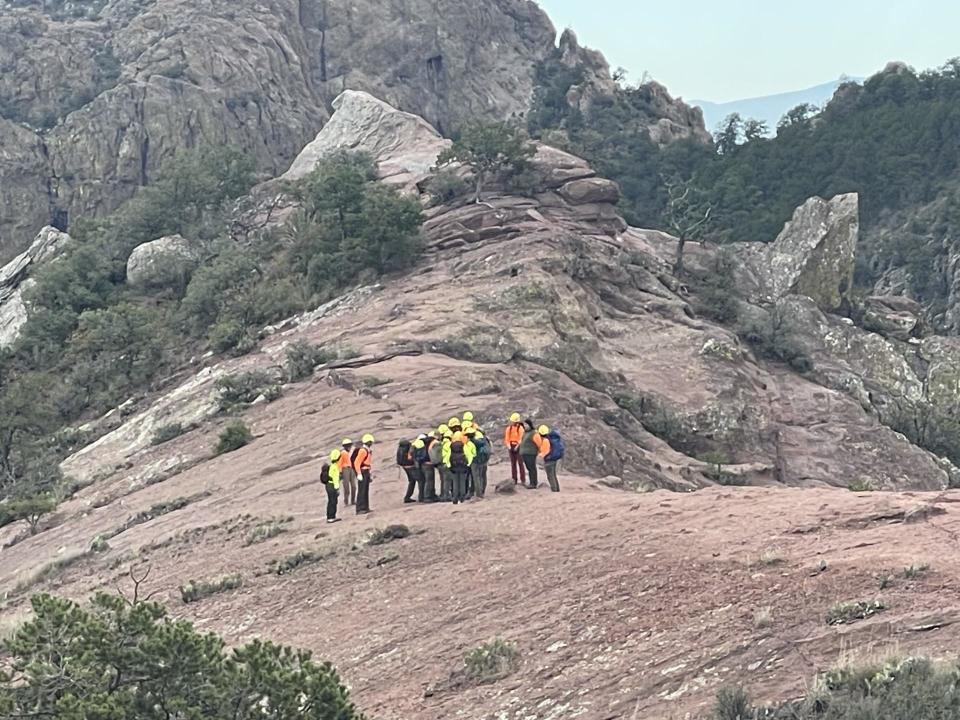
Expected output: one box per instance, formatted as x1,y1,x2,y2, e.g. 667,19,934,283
0,148,422,522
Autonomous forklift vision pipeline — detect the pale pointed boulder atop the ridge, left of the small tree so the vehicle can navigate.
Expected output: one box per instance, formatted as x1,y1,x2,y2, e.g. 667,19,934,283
282,90,450,191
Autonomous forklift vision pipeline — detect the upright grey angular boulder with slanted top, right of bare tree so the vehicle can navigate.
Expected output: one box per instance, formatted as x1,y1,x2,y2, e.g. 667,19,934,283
737,193,860,312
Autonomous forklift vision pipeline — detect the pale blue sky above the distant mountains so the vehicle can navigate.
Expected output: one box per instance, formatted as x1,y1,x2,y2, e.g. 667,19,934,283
538,0,960,102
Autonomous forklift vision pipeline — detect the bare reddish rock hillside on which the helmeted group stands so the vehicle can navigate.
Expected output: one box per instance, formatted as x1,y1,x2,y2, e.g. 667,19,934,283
0,88,960,720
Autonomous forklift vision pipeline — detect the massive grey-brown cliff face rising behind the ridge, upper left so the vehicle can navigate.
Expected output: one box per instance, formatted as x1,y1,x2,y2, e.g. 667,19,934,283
0,0,702,259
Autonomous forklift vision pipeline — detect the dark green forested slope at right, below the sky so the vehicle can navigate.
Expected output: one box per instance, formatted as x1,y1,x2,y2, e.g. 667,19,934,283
528,57,960,301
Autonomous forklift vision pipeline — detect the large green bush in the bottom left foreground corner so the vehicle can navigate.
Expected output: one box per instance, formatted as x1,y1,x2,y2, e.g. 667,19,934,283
0,588,362,720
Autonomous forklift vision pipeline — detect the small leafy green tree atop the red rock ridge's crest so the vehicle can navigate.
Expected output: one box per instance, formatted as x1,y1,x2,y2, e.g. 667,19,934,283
437,122,536,202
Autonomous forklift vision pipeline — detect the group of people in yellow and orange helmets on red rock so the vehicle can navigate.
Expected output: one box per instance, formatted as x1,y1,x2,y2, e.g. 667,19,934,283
321,412,566,523
